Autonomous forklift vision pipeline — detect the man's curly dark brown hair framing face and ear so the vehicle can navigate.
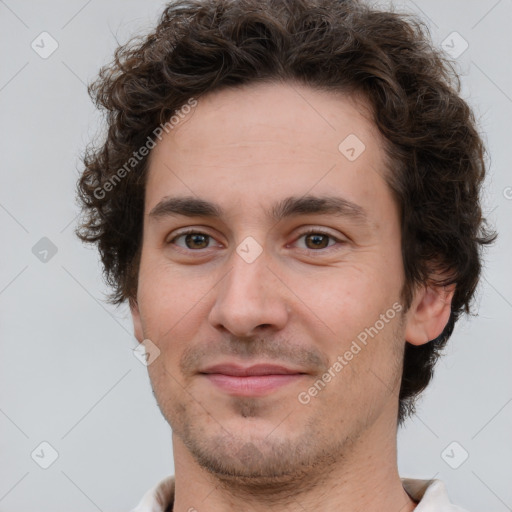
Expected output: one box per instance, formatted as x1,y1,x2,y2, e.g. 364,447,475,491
75,0,496,425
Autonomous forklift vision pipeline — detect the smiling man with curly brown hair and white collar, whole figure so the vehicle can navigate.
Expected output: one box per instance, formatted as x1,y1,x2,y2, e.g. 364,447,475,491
77,0,494,512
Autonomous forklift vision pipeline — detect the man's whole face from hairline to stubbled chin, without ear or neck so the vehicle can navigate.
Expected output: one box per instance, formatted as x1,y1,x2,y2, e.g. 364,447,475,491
132,84,412,488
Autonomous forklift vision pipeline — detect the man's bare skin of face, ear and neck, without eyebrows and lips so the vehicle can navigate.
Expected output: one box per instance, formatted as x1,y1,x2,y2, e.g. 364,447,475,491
131,83,453,512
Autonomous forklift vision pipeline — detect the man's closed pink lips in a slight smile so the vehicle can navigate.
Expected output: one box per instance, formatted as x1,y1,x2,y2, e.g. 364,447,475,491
200,364,306,396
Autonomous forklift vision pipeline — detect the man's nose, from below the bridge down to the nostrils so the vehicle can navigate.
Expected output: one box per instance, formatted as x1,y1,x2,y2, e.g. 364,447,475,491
208,246,289,337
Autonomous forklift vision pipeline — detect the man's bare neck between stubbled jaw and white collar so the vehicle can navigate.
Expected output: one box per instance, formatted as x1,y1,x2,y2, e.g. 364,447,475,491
173,412,416,512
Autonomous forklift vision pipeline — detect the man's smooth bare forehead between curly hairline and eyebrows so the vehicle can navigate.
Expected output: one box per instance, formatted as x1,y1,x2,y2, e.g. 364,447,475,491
146,79,389,222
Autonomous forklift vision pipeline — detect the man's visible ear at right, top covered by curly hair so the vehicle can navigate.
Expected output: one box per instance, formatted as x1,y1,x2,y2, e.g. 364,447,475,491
405,285,455,345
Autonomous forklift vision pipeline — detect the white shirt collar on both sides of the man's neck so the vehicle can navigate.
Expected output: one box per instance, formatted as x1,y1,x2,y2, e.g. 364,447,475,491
131,476,466,512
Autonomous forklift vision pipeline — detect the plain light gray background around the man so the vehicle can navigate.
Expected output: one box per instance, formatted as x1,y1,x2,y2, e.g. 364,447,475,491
0,0,512,512
